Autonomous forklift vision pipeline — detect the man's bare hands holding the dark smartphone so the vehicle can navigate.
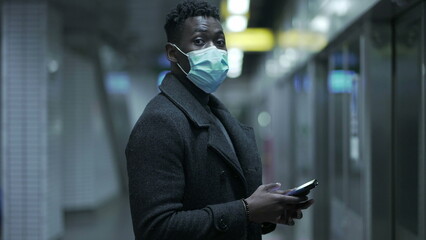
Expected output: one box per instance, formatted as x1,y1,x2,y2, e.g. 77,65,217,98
246,183,313,225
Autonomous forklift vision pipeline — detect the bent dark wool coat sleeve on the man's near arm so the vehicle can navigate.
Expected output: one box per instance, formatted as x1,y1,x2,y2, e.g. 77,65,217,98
126,111,247,240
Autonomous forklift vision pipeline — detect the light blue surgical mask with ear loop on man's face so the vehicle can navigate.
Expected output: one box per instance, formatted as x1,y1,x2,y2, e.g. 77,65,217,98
170,43,229,93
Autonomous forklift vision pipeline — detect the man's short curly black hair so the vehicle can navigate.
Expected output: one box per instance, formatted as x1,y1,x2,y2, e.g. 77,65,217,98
164,0,220,43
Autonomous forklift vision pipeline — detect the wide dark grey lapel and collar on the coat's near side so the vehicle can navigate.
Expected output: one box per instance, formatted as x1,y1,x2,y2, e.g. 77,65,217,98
160,74,247,187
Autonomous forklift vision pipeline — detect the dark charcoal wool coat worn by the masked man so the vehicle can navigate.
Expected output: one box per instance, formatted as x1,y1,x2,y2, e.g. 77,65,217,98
126,74,275,240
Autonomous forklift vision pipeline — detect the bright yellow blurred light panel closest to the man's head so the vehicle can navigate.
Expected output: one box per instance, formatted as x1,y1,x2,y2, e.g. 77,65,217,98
225,28,275,52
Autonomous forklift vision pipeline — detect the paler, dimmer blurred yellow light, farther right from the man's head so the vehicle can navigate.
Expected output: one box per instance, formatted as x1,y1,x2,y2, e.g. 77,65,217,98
278,29,328,52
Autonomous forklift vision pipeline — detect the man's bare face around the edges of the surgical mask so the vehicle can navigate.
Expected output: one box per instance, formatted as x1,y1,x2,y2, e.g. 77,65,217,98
176,16,226,72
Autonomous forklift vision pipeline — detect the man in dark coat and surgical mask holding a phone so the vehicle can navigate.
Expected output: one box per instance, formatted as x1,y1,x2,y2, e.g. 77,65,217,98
126,1,312,240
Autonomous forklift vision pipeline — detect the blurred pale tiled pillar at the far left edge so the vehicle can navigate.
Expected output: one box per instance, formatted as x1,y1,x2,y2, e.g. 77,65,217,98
1,1,61,240
